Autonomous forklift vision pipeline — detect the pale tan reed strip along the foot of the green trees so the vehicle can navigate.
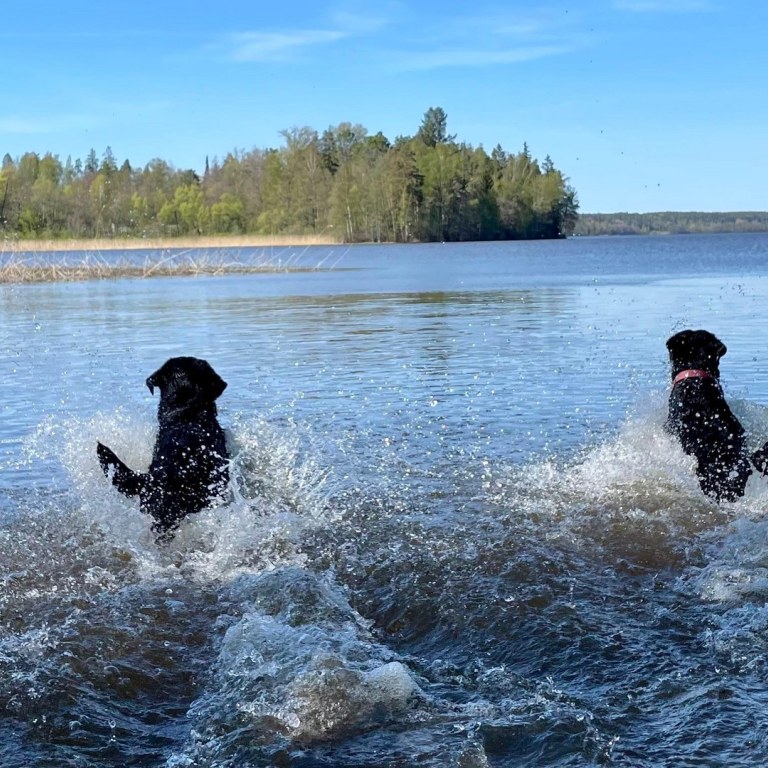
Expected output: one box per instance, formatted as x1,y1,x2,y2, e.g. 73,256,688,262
0,235,339,254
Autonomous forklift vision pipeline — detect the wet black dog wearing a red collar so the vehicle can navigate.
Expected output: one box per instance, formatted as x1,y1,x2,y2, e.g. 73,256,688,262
667,330,762,501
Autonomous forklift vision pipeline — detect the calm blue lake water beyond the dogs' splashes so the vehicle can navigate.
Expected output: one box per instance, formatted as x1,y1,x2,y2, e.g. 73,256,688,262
0,236,768,481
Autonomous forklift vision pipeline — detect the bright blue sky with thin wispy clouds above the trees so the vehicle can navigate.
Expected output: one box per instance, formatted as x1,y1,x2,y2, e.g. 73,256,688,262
0,0,768,212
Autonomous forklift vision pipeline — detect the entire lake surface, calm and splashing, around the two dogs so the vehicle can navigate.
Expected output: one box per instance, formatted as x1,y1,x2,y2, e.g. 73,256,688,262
0,235,768,768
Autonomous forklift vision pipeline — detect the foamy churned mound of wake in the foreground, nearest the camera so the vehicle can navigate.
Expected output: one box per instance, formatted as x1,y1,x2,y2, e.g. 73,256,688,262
174,568,420,755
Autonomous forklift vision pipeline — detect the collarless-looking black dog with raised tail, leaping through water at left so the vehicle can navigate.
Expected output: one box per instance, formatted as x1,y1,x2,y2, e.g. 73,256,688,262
96,357,229,539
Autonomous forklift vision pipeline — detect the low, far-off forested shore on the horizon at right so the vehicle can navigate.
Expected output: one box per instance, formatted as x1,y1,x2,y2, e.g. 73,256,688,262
574,211,768,235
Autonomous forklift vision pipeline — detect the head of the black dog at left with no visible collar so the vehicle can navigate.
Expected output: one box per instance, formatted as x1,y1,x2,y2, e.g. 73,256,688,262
147,357,227,411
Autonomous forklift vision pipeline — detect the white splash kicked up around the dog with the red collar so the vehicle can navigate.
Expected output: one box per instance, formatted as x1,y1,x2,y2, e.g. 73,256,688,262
474,393,768,568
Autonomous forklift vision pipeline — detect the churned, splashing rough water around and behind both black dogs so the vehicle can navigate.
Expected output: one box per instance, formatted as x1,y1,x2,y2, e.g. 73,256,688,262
7,392,768,768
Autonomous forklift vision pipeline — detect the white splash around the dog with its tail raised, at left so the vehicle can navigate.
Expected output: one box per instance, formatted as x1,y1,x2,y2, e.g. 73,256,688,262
19,409,333,579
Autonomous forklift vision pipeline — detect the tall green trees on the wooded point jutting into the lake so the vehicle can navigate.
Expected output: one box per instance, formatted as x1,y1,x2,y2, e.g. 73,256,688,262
0,107,578,242
